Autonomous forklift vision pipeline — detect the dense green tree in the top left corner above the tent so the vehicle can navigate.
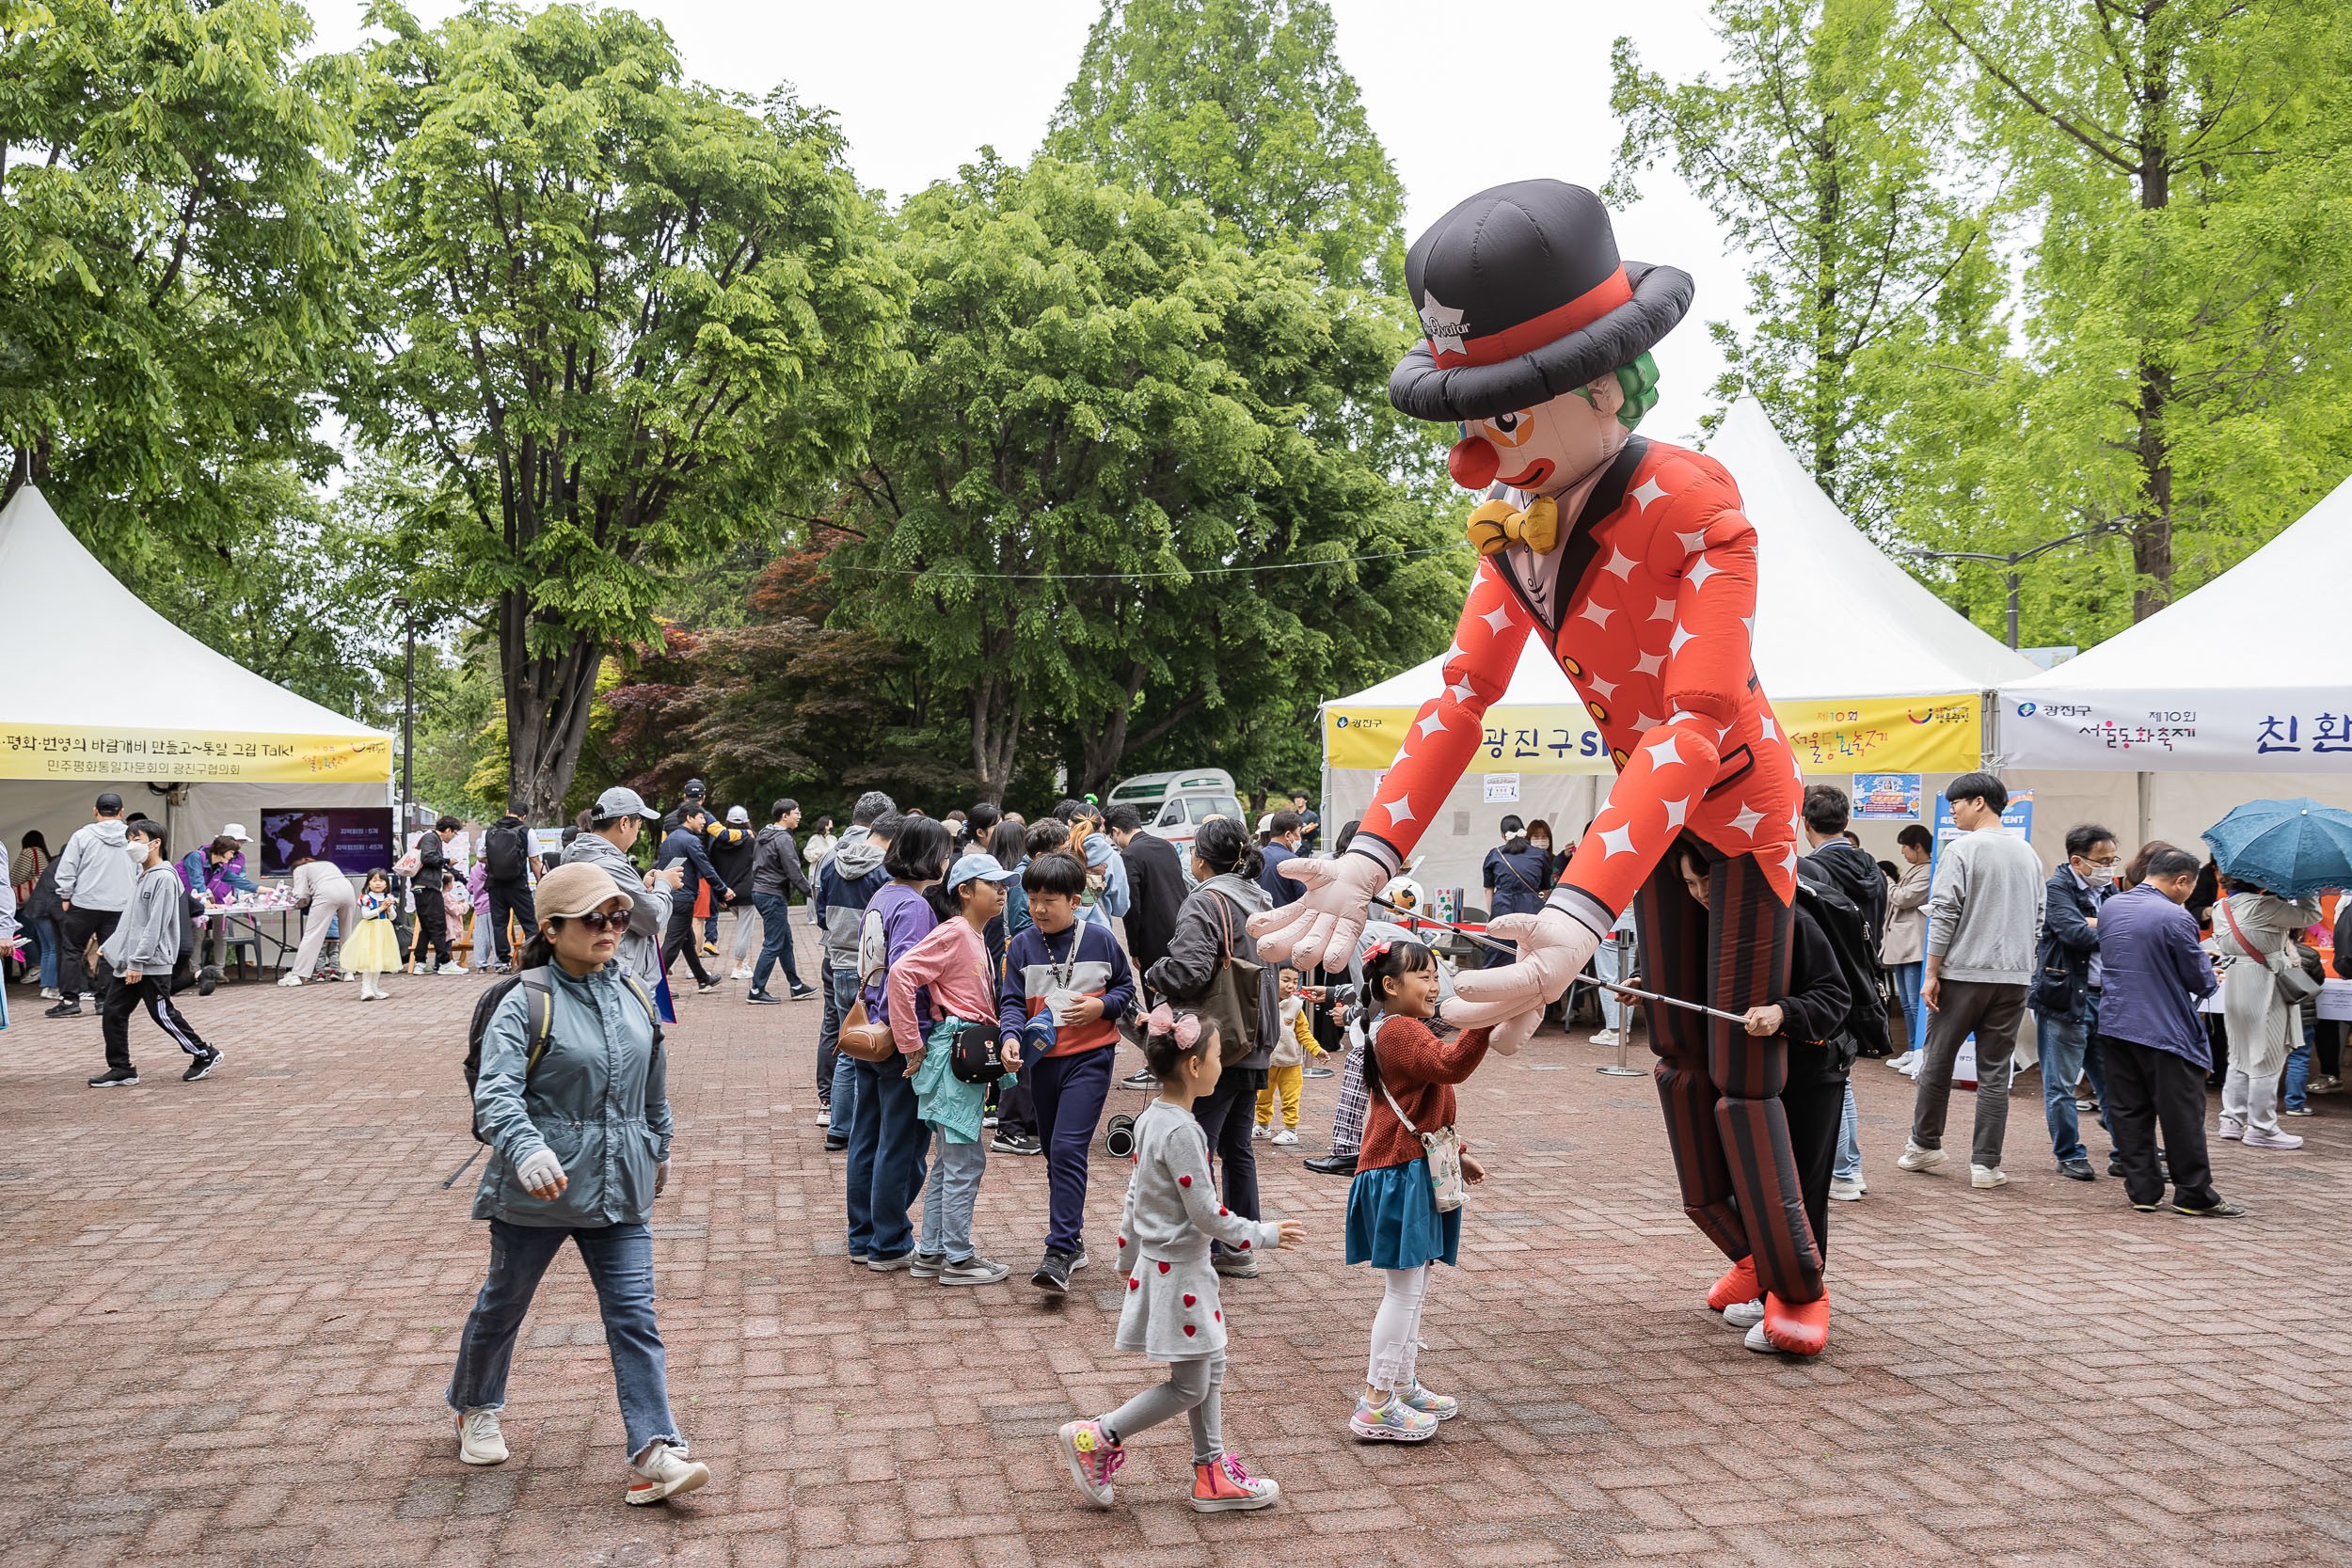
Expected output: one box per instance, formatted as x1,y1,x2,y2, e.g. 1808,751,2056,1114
0,0,358,557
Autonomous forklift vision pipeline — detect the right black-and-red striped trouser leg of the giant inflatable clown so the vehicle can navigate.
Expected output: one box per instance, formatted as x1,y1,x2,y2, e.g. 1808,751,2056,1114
1703,856,1820,1303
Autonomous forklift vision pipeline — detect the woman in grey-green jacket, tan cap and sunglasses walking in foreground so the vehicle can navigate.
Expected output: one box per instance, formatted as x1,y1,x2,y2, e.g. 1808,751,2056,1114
450,863,710,1502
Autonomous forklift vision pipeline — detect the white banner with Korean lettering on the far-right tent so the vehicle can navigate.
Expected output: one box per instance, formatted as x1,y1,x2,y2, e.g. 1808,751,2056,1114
1999,690,2352,773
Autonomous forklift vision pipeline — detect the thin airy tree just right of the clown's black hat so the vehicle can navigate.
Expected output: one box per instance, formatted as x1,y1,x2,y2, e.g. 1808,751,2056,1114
1609,0,2002,527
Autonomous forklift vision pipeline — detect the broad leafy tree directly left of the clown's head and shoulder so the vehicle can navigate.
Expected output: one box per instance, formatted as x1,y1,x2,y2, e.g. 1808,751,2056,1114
826,160,1454,800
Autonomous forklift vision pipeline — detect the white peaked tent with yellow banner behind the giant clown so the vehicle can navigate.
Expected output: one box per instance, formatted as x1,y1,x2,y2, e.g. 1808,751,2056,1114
1322,397,2035,889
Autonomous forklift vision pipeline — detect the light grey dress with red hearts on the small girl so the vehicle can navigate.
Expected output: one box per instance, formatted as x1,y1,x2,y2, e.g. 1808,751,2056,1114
1115,1098,1282,1361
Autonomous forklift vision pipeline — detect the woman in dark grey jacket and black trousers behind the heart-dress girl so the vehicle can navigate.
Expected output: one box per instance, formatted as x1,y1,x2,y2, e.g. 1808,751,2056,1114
1143,816,1282,1279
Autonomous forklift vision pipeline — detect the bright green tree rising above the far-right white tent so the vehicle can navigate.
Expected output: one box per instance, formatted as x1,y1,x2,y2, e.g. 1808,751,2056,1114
1917,0,2352,625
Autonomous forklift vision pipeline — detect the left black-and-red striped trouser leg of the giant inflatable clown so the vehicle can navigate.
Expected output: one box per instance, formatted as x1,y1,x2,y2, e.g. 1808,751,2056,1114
1632,839,1748,1262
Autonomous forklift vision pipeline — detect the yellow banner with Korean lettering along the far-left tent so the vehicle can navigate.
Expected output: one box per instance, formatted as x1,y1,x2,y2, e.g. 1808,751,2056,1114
0,721,393,783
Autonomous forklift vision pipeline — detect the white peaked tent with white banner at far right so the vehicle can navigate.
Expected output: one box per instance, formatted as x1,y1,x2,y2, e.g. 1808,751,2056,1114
1999,480,2352,848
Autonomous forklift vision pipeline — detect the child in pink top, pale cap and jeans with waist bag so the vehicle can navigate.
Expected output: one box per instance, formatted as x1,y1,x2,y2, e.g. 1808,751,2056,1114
884,853,1011,1286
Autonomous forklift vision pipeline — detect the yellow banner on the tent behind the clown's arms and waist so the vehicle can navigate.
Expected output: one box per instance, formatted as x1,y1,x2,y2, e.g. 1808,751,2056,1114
1325,691,1983,773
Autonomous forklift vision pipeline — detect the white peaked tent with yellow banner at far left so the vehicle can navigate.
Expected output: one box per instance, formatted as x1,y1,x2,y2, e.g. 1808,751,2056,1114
0,484,393,870
